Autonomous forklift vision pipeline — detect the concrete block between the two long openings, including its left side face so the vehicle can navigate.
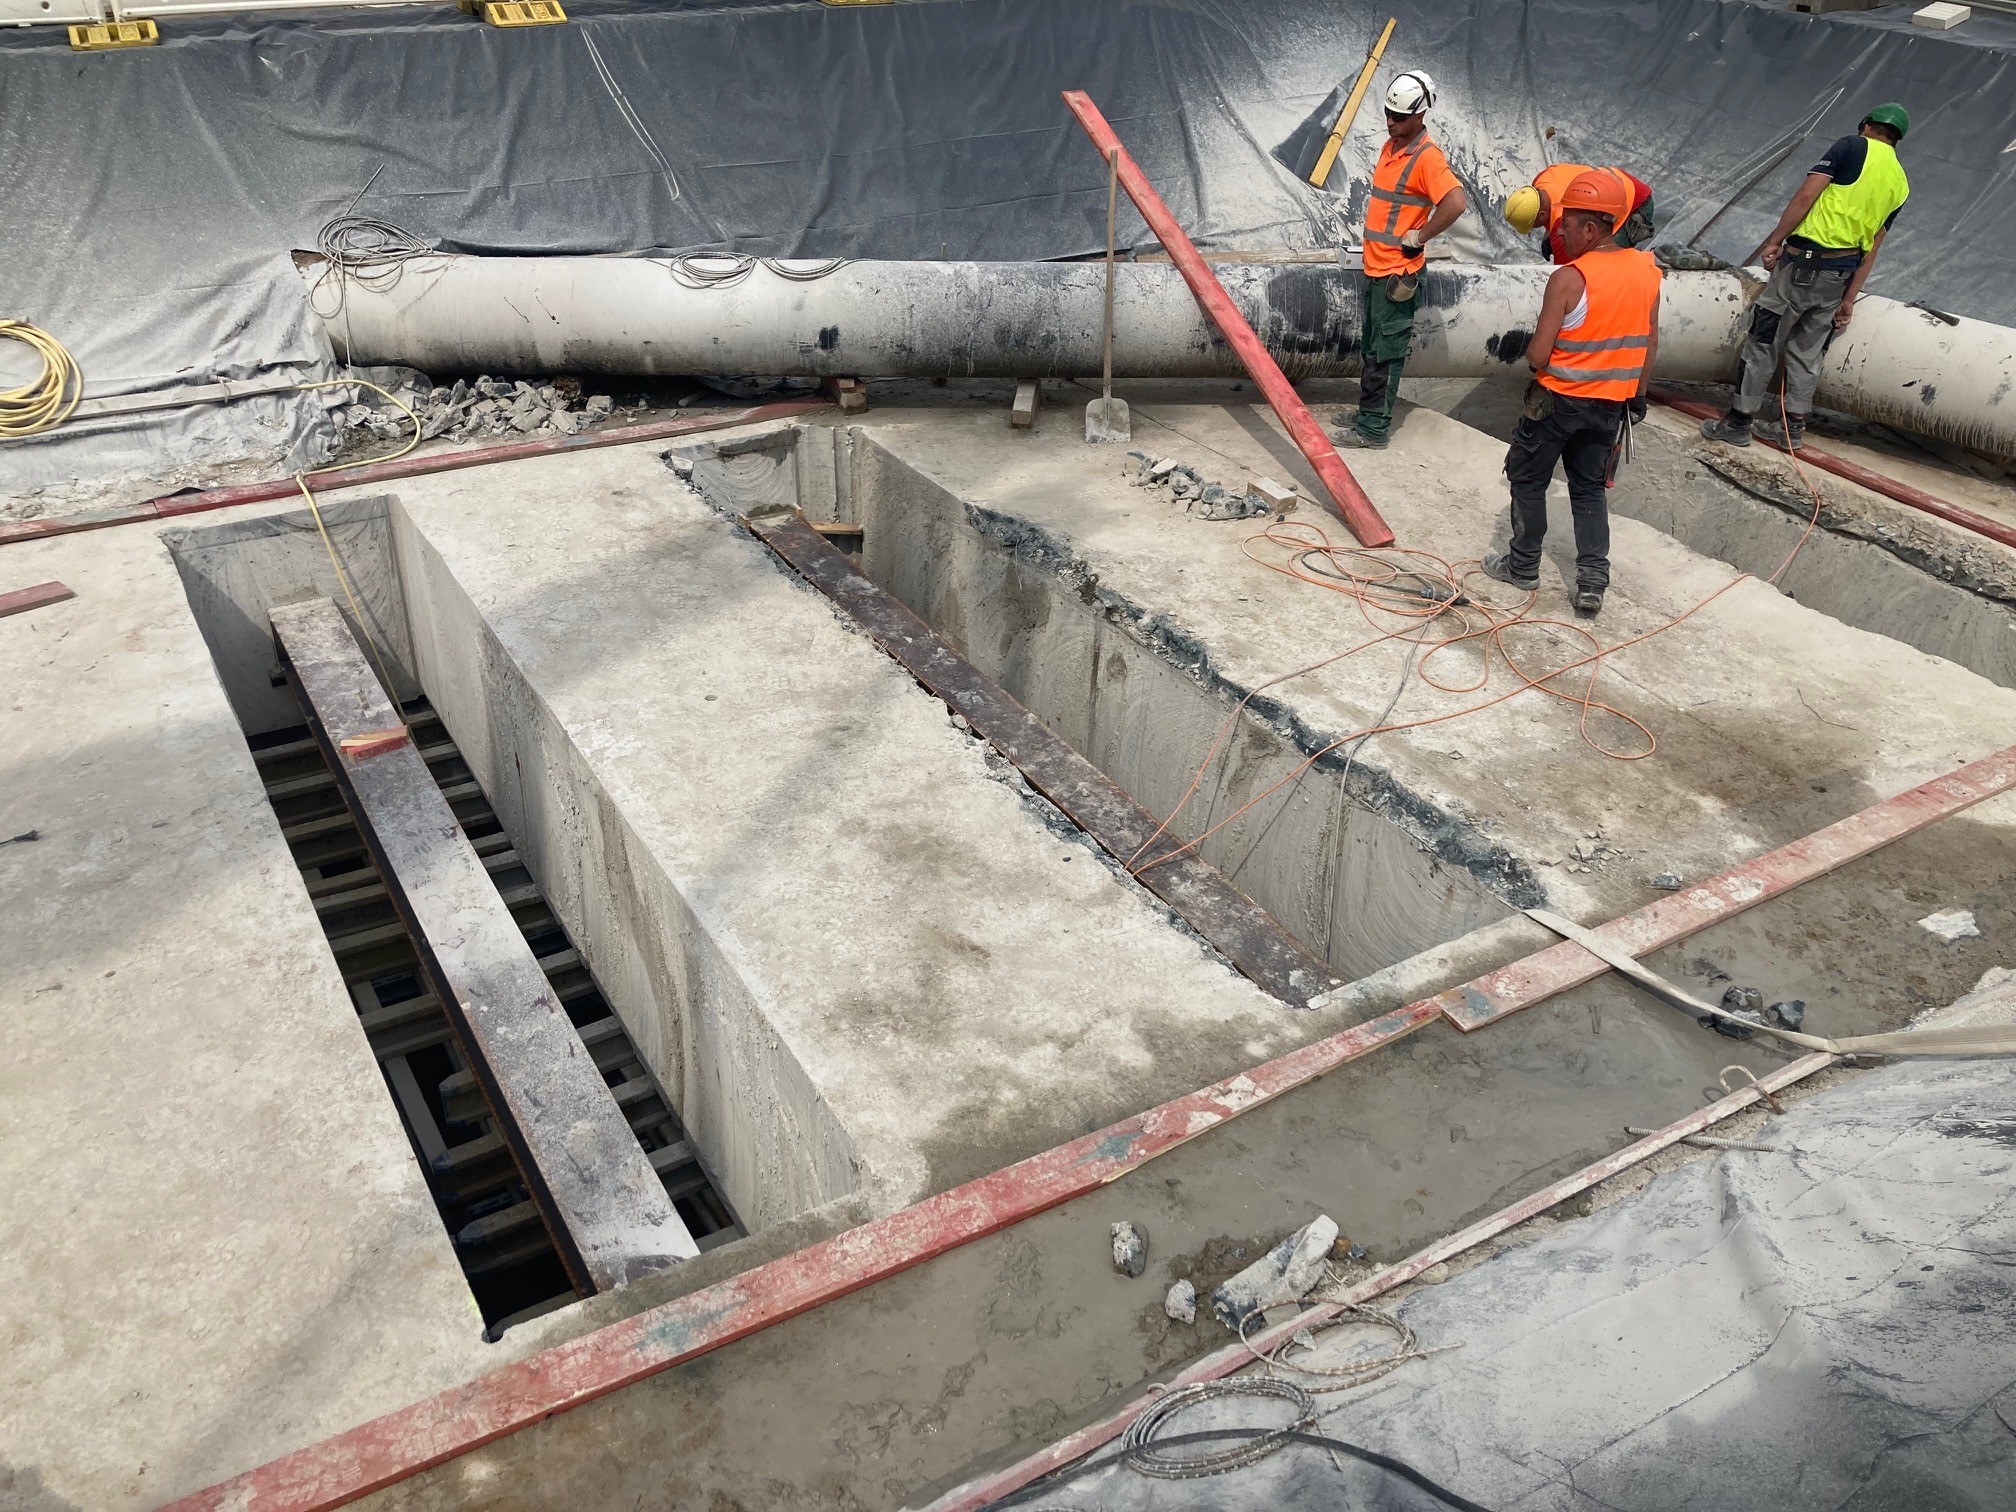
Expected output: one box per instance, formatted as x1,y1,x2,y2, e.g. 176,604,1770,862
330,448,1310,1226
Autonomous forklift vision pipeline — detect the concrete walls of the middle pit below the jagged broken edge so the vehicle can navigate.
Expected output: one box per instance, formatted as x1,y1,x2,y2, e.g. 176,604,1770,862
689,425,1512,982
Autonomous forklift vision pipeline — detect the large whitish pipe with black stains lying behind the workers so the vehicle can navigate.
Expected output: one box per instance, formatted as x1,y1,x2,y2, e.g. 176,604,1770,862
302,256,2016,454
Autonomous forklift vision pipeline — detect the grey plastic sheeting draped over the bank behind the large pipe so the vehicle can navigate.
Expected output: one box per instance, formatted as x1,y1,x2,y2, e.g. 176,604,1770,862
0,0,2016,490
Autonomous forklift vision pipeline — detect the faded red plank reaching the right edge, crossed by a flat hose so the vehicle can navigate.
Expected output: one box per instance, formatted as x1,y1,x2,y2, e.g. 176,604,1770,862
1439,746,2016,1032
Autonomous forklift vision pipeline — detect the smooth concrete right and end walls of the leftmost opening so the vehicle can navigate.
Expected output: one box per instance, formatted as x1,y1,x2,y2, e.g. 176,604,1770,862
165,498,857,1232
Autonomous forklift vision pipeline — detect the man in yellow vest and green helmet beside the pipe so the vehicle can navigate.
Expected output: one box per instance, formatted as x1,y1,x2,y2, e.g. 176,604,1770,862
1702,105,1911,452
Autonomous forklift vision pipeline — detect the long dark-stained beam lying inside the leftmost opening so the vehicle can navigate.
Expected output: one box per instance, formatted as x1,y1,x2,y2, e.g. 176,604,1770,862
272,599,700,1294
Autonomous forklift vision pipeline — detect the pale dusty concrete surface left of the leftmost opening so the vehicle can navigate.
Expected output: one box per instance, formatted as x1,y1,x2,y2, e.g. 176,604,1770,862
0,528,502,1512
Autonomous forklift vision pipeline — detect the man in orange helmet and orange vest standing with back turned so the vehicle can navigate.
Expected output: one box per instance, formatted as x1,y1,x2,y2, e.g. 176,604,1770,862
1484,171,1659,617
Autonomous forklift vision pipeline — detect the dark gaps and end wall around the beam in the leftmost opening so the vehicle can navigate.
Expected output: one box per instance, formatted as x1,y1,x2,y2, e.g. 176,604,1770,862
167,500,744,1339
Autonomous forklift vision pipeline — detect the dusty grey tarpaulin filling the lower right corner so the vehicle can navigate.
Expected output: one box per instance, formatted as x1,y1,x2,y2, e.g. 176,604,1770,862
1034,1020,2016,1512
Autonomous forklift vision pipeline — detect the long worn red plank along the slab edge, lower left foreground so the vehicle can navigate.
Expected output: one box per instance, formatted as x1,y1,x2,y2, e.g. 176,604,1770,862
167,1002,1437,1512
